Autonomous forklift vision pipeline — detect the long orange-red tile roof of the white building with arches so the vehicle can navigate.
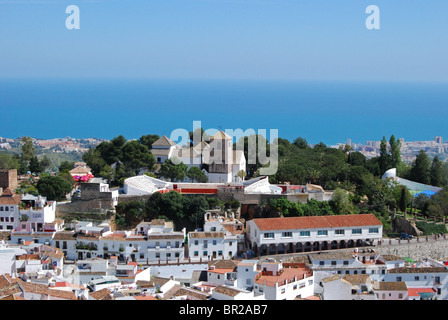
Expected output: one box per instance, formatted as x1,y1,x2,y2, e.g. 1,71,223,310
253,214,382,231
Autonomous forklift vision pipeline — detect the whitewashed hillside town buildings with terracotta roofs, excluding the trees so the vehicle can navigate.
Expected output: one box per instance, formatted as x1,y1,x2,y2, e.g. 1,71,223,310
0,131,448,301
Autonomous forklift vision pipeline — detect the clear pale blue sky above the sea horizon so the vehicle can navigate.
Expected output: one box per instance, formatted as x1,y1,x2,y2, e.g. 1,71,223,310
0,0,448,82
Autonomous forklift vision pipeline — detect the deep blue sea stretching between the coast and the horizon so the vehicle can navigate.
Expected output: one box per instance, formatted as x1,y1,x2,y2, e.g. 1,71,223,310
0,78,448,145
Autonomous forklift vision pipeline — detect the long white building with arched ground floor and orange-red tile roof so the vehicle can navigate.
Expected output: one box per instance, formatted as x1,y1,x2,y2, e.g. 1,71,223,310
246,214,383,254
